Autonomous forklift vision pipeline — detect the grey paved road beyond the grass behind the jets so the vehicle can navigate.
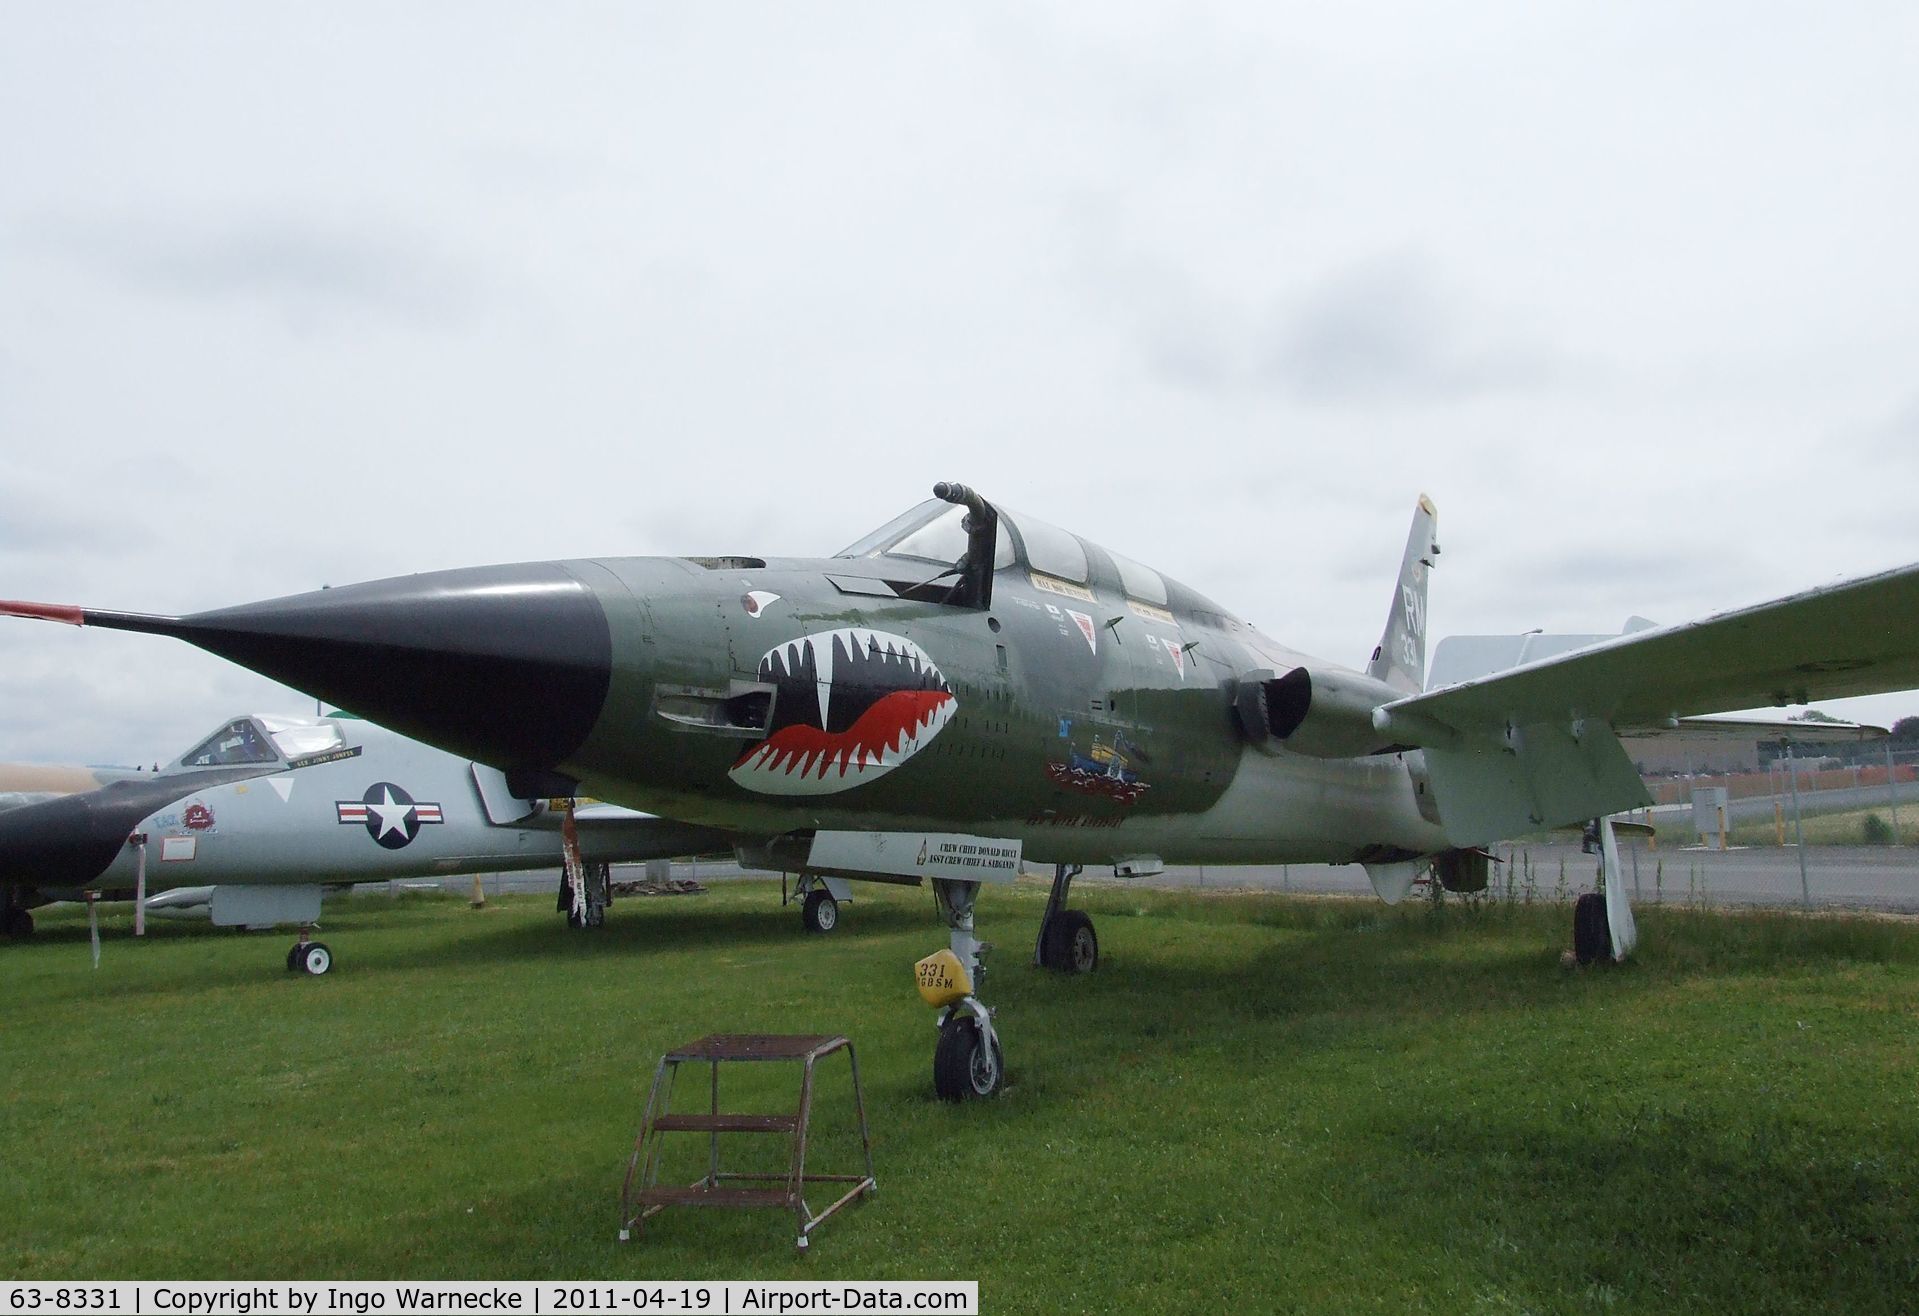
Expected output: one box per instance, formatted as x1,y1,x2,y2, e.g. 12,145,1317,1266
393,842,1919,913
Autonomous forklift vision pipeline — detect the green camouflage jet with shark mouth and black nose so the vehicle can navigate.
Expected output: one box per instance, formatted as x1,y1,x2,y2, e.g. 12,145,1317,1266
0,483,1919,1097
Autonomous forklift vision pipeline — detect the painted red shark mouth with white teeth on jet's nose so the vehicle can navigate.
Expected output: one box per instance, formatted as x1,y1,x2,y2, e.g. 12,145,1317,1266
727,627,960,794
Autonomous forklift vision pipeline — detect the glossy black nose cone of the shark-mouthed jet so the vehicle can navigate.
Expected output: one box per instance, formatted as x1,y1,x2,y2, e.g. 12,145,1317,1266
173,562,612,769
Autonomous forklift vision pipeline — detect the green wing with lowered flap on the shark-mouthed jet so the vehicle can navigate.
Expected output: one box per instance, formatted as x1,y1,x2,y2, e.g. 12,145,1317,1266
1374,564,1919,846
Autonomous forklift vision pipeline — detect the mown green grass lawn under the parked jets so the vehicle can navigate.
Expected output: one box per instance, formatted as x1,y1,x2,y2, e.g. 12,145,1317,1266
0,882,1919,1314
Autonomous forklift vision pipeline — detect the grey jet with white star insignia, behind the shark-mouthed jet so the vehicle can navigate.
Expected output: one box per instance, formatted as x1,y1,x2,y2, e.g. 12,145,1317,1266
0,716,727,973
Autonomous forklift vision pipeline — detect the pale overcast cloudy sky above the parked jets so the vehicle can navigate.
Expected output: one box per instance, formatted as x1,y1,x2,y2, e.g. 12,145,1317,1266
0,0,1919,762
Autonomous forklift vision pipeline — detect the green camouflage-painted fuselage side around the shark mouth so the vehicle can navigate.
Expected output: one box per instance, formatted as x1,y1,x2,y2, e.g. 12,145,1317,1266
557,529,1445,863
